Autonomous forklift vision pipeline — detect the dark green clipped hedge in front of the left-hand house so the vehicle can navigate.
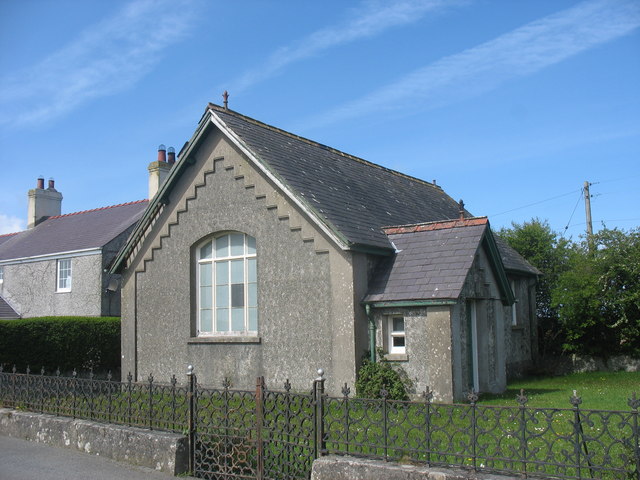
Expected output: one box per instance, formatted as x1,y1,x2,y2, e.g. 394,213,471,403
0,317,120,373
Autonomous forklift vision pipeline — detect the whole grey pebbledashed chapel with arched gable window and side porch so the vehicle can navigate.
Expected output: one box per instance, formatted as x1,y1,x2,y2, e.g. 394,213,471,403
111,104,539,401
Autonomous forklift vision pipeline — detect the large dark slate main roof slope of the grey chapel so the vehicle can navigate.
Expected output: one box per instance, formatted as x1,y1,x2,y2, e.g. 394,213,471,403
209,104,468,248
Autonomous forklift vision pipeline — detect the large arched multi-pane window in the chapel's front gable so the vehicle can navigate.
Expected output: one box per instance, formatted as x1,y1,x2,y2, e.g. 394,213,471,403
197,233,258,335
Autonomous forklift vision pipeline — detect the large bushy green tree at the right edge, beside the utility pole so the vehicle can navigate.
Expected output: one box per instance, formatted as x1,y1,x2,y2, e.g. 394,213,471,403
552,229,640,358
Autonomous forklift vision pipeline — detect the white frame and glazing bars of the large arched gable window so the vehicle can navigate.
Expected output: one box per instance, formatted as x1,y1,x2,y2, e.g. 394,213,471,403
196,232,258,337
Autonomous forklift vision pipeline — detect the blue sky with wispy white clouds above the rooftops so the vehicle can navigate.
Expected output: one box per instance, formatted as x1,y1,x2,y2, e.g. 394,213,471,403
0,0,640,239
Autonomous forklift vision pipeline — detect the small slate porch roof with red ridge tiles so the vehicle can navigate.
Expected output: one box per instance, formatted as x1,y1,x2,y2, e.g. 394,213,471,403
364,218,488,302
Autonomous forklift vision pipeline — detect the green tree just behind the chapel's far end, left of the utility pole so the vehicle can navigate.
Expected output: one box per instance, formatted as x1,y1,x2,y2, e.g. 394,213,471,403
498,218,574,355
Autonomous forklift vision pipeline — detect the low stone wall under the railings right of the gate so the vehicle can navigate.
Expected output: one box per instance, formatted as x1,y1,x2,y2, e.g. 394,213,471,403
311,455,519,480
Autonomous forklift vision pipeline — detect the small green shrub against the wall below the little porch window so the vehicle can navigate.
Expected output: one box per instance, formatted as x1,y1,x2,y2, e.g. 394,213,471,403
356,357,409,400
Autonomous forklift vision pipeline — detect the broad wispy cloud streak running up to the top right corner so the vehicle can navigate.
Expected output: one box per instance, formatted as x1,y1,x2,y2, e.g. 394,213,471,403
305,0,640,128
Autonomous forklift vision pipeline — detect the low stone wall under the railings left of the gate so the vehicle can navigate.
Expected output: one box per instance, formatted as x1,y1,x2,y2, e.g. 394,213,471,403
0,408,189,475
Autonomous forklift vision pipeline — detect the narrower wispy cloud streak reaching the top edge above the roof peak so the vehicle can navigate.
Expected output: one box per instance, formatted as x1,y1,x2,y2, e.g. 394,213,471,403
229,0,470,93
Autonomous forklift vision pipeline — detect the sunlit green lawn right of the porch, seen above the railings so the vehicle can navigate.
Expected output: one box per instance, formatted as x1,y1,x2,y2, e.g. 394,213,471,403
478,372,640,410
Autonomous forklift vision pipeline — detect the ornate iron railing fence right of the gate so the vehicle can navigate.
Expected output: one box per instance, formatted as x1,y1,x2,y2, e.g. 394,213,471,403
324,386,640,479
